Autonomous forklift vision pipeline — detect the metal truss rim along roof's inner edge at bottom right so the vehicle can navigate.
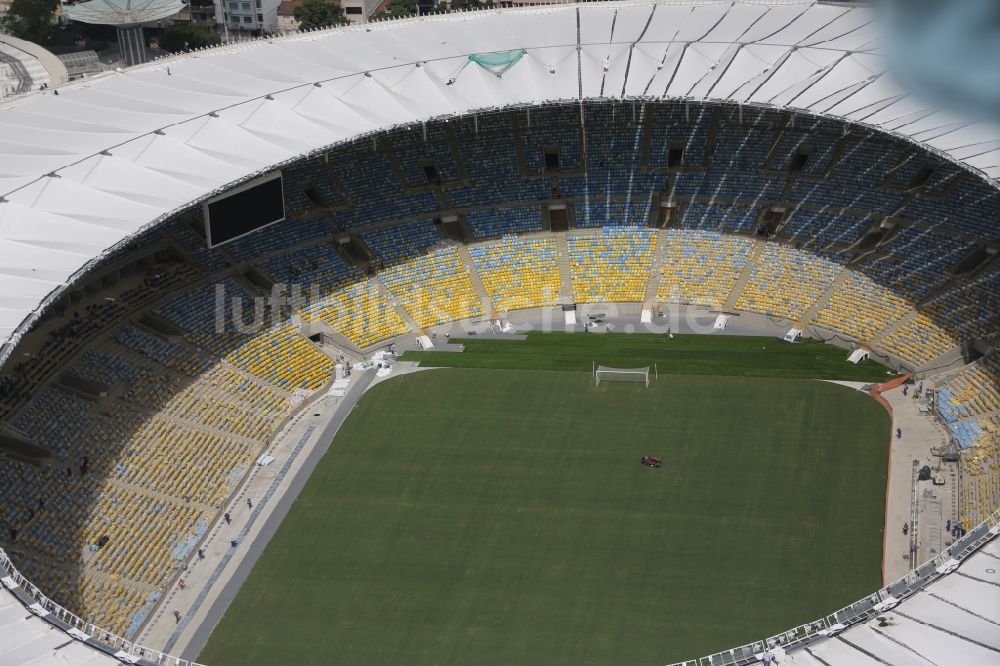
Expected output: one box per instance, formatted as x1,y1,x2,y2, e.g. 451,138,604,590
669,509,1000,666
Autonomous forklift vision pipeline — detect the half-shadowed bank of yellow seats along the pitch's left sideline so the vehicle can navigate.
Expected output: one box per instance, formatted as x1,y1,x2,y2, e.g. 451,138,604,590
0,338,295,636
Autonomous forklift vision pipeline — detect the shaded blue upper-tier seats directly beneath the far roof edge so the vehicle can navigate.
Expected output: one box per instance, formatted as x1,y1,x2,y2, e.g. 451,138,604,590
244,103,1000,248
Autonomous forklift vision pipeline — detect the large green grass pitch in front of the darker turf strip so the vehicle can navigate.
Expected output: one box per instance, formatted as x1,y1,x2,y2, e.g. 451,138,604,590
199,364,890,666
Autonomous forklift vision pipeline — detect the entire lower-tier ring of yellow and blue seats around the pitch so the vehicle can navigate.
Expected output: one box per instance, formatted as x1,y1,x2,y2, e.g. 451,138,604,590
0,226,988,635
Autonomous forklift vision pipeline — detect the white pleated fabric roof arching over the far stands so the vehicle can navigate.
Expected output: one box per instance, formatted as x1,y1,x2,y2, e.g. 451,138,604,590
0,0,1000,361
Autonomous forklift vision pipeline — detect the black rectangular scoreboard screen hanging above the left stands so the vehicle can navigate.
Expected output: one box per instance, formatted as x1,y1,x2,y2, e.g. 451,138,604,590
204,172,285,247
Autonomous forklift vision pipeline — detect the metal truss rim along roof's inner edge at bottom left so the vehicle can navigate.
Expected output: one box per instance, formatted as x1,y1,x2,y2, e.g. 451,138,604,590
0,549,203,666
